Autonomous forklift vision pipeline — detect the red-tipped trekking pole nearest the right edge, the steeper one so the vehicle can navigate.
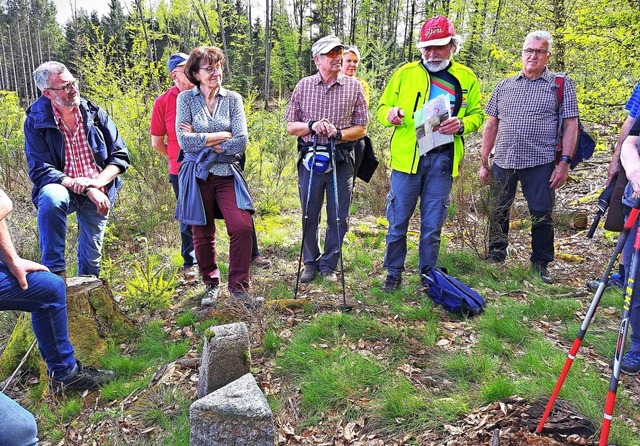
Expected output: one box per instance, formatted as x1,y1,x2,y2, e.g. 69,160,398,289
599,214,640,446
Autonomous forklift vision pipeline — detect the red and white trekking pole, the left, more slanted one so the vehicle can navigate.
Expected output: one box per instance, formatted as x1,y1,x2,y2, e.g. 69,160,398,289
536,200,640,434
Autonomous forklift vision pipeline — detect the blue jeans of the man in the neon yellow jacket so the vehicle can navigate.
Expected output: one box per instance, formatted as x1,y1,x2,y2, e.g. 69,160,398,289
382,150,453,277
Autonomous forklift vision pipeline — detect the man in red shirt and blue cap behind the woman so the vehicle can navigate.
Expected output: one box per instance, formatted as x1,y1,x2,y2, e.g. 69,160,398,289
151,53,198,282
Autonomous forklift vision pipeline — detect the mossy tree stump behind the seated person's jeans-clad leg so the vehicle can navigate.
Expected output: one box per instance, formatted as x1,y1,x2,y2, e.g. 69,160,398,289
0,277,136,377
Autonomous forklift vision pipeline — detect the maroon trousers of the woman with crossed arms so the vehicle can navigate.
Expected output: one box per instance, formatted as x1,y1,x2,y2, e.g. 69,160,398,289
192,174,252,291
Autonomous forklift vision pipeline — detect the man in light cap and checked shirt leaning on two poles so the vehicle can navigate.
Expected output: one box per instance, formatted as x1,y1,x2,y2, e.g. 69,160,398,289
285,36,369,283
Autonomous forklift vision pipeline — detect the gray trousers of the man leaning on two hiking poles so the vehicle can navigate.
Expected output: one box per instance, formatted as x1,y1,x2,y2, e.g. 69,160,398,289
298,158,353,273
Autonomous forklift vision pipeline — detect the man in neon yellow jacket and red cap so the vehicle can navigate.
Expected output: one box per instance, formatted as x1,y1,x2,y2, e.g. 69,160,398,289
377,16,484,292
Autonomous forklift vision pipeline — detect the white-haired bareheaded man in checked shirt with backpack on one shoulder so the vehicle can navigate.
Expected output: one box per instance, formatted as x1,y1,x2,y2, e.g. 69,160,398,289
479,31,578,283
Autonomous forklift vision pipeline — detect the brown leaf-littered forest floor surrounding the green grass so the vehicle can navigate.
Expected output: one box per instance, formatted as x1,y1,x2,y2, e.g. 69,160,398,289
7,148,640,446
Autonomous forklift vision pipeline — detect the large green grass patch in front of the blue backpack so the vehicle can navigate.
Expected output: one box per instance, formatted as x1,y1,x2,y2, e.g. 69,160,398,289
269,240,633,444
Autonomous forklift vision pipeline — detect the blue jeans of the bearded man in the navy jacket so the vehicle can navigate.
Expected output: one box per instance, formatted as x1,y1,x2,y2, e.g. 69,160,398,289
37,184,108,277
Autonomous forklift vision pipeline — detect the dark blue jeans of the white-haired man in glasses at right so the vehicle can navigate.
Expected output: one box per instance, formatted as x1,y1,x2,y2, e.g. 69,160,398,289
489,162,556,266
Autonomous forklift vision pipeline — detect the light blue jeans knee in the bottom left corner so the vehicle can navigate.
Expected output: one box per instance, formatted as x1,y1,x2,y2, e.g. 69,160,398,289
0,392,38,446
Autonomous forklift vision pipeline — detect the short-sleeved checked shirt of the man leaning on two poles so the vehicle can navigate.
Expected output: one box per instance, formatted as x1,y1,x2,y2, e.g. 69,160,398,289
284,72,369,144
